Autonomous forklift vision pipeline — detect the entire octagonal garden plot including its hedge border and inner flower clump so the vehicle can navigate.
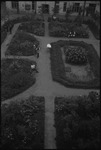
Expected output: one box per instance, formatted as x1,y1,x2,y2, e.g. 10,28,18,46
50,40,100,89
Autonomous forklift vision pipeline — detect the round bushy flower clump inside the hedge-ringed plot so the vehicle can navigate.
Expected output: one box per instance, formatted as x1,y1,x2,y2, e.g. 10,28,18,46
65,47,87,65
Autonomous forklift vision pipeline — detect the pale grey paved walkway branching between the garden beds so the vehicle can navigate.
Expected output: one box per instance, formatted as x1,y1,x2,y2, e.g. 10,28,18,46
1,14,100,149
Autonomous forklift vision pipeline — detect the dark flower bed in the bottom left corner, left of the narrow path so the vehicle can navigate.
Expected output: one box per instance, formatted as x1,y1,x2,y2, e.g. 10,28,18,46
1,96,45,149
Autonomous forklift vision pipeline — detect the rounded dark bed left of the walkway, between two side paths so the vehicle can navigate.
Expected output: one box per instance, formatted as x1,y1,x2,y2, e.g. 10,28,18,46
5,31,39,56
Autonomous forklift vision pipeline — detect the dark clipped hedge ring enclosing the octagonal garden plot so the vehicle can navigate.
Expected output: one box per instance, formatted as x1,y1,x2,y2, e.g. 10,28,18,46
50,40,100,89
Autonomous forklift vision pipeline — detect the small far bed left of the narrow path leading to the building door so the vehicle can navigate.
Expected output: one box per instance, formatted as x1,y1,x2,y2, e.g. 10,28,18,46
18,21,45,36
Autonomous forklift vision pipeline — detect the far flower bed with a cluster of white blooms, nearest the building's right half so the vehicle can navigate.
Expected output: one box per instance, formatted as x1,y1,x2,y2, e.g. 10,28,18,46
49,21,89,38
